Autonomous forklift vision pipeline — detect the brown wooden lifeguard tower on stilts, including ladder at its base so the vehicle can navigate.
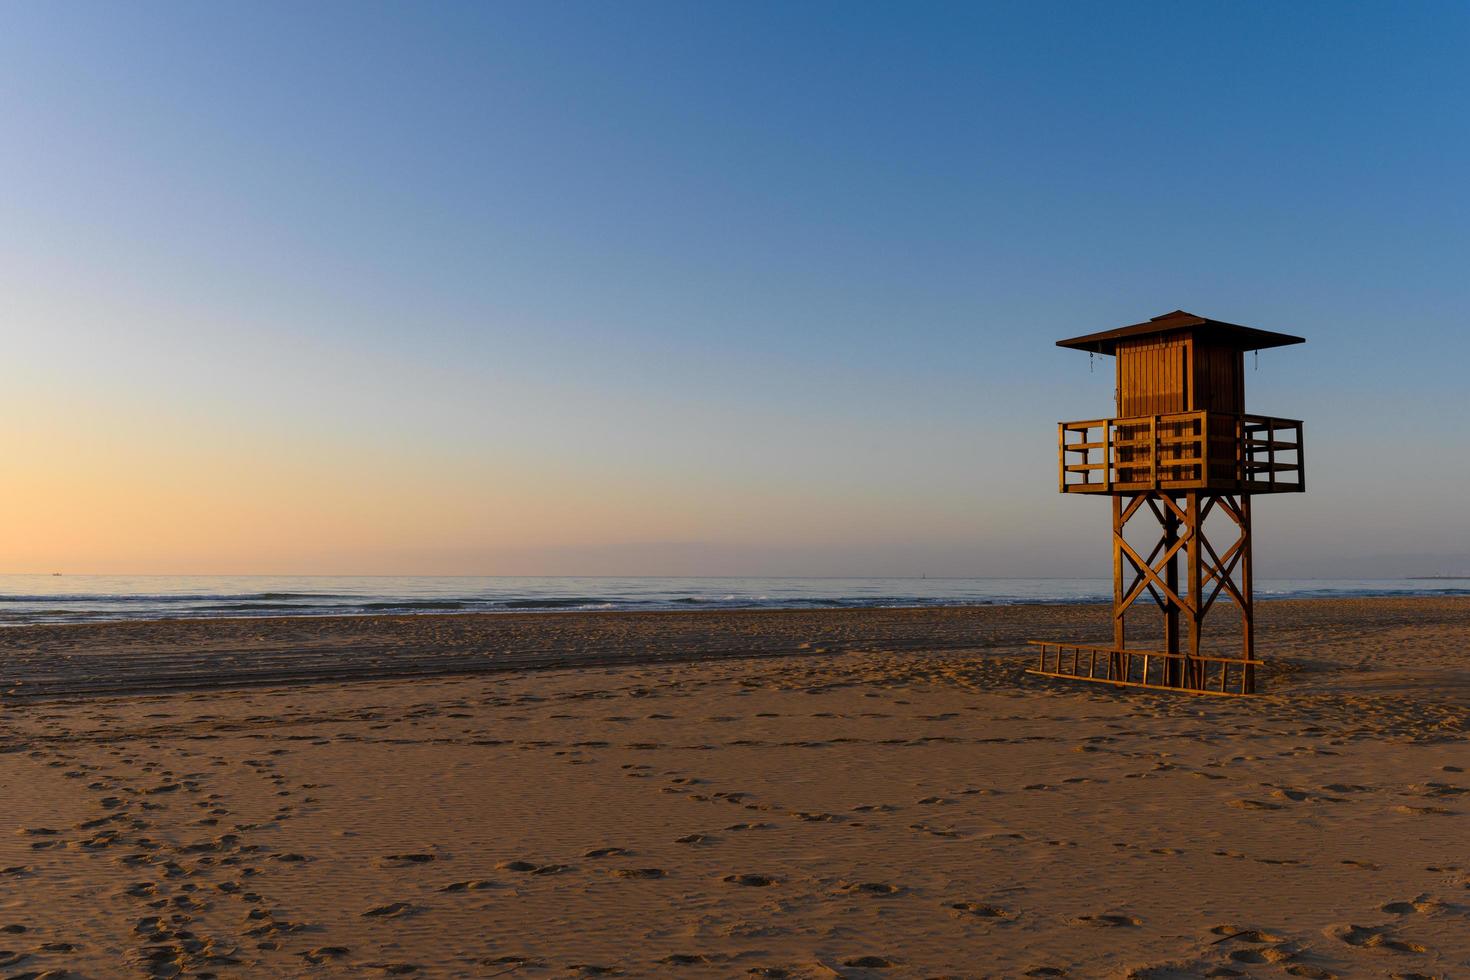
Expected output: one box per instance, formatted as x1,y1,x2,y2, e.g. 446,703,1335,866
1029,310,1305,695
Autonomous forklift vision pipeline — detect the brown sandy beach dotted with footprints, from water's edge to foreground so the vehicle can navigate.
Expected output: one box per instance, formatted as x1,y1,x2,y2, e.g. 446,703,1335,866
0,599,1470,977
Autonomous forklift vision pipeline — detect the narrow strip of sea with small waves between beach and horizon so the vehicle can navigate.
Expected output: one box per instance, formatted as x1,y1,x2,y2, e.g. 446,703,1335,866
0,574,1470,626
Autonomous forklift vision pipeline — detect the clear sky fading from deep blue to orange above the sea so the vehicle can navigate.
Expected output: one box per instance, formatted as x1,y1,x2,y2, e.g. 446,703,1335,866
0,0,1470,577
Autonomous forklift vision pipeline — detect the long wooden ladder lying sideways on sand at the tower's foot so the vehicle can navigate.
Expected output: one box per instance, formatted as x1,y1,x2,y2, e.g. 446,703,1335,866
1026,639,1263,695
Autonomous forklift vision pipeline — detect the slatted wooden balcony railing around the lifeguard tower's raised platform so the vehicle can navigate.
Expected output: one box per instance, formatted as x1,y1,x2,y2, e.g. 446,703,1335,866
1057,411,1307,494
